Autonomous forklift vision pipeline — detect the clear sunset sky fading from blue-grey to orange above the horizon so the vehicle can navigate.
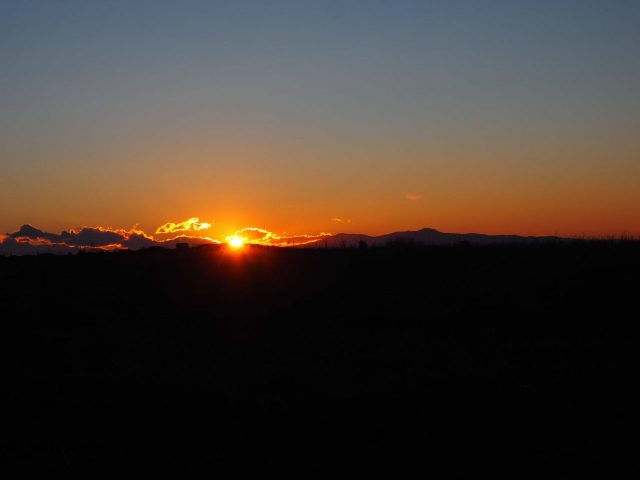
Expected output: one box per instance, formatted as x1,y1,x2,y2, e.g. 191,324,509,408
0,0,640,239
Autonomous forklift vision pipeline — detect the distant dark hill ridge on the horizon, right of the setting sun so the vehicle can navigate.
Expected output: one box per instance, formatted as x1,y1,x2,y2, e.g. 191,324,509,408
309,228,566,248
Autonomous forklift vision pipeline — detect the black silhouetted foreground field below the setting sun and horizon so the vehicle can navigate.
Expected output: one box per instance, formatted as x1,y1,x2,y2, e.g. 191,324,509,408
0,242,640,472
